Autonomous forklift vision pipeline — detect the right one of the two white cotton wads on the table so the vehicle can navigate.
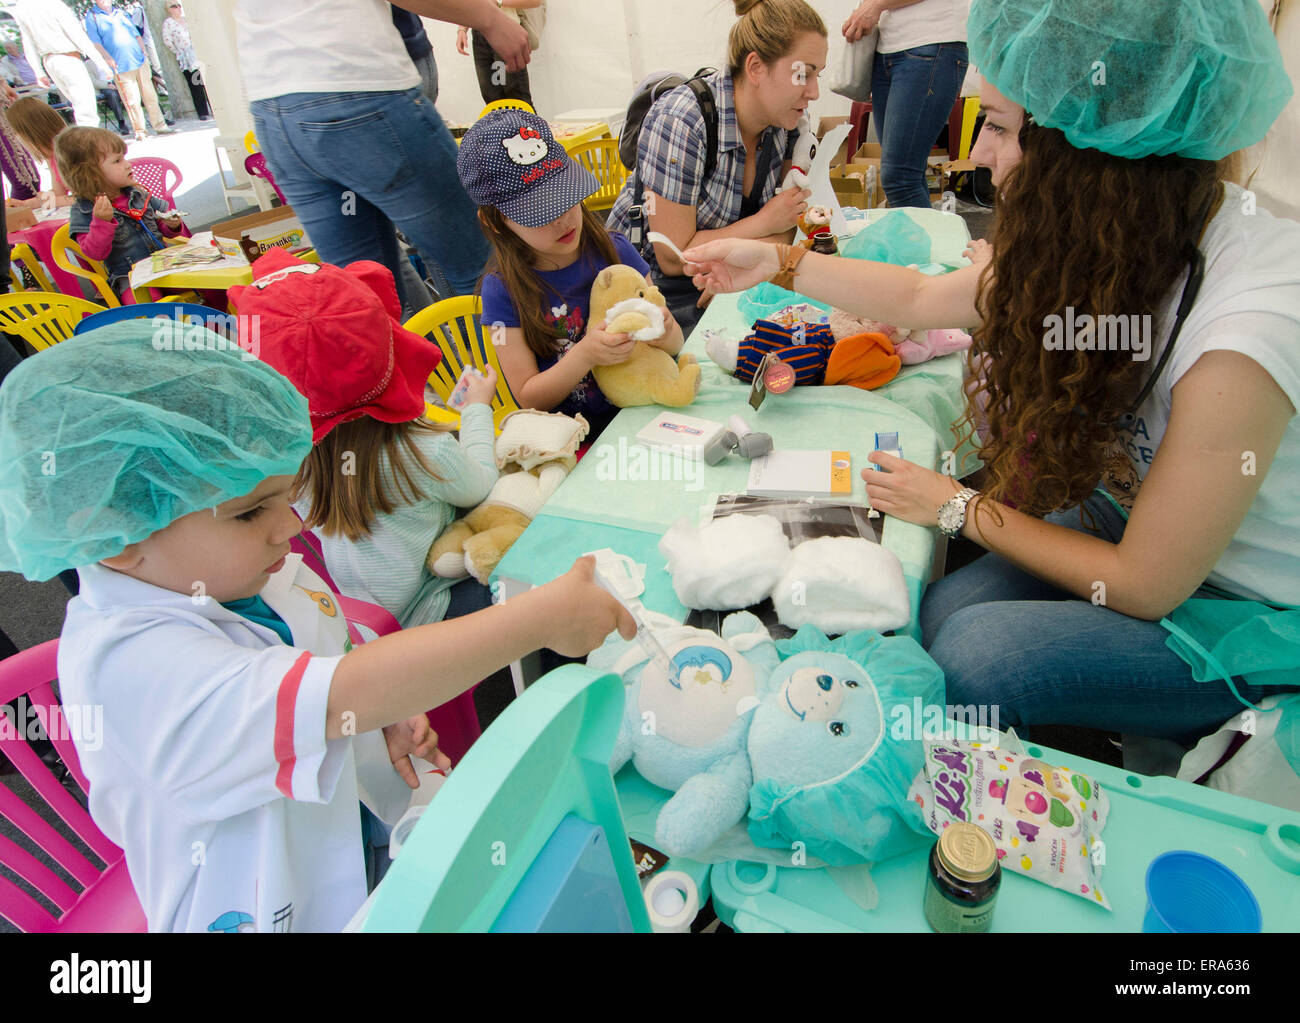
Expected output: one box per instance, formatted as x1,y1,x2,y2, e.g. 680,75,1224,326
772,537,911,636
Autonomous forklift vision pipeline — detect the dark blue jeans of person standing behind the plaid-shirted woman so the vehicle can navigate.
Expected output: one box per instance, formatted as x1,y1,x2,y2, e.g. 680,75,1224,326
871,43,970,208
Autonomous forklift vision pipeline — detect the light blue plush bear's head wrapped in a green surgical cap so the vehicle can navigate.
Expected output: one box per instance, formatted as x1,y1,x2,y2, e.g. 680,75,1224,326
749,625,944,864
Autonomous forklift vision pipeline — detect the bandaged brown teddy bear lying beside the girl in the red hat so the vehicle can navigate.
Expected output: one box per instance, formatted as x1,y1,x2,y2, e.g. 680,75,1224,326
425,408,589,586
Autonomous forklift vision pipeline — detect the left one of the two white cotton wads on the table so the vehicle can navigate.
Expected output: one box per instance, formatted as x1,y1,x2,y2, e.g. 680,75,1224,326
659,515,790,611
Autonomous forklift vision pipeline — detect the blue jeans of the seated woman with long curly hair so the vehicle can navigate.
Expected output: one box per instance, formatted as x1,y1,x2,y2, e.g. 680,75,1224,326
920,494,1294,744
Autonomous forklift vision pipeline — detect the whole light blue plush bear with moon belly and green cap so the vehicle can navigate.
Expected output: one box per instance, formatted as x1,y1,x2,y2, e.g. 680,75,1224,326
588,611,944,864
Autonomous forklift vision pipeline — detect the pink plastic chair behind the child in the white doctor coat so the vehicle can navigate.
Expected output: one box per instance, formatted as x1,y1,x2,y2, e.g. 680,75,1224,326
0,640,147,933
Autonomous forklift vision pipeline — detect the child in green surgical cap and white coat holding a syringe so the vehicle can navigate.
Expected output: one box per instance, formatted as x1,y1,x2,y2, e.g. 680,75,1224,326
0,320,633,931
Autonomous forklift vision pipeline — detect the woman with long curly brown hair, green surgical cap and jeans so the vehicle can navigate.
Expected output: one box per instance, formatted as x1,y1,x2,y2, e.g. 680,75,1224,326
685,0,1300,741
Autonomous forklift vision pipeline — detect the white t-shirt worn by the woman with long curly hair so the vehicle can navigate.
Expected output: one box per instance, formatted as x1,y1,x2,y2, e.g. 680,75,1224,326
1121,185,1300,606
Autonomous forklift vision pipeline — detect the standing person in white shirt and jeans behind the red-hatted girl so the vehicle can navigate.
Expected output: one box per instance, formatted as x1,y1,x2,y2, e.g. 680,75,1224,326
235,0,528,308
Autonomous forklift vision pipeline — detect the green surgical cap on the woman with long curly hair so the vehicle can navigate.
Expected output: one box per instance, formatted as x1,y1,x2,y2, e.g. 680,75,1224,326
967,0,1292,160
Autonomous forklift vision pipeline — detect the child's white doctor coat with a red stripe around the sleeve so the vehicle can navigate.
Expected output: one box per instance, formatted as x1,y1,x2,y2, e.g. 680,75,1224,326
59,554,410,931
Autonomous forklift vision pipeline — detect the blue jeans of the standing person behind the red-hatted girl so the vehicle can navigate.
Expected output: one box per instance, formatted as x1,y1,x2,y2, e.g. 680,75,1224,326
252,88,489,300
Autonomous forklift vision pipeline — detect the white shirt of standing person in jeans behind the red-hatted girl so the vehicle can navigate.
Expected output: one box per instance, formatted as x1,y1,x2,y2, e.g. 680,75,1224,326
235,0,420,103
